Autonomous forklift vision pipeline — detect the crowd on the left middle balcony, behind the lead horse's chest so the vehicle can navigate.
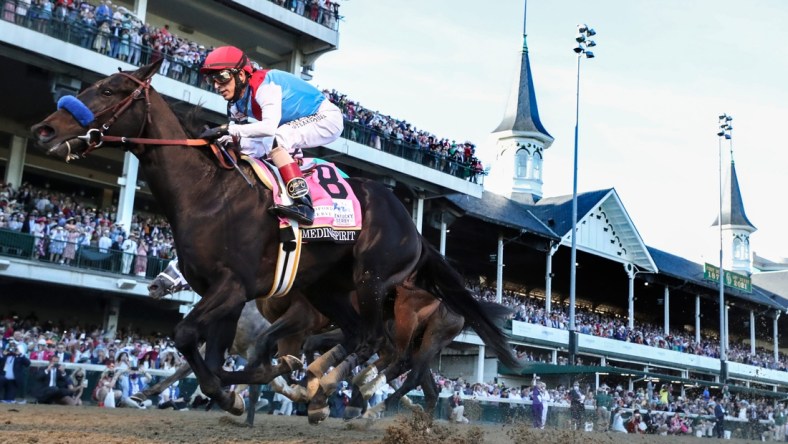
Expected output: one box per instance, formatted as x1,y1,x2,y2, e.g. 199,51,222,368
0,182,177,278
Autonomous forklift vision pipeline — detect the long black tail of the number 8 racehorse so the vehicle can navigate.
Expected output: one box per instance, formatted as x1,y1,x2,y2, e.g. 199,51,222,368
416,241,522,369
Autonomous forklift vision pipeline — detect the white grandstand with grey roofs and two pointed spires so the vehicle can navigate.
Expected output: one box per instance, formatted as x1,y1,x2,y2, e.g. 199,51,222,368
0,0,788,426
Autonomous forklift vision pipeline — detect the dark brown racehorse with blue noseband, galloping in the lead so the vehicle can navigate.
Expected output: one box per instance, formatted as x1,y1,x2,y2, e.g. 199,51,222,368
31,60,518,424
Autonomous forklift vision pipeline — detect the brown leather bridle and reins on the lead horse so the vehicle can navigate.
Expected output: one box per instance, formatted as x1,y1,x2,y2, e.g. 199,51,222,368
77,72,238,170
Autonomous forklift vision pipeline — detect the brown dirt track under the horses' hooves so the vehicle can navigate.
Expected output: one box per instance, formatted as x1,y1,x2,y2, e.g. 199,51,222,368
0,404,768,444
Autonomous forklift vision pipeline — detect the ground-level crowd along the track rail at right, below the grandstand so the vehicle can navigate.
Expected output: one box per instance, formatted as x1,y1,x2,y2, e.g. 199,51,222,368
428,366,788,441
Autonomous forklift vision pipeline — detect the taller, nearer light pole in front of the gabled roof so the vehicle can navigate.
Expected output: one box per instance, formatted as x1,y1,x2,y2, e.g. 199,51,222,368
569,25,596,365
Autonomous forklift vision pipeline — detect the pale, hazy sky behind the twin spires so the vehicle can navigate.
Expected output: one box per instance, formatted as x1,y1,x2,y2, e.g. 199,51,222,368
313,0,788,263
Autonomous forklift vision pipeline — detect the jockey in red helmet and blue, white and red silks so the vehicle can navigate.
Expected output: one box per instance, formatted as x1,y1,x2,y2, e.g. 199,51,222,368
200,46,343,225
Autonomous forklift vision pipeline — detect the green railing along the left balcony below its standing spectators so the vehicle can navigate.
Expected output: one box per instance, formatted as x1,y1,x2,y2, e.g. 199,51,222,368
0,229,170,279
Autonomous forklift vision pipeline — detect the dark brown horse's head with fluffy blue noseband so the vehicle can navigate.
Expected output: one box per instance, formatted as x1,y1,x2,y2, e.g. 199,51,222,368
30,60,161,161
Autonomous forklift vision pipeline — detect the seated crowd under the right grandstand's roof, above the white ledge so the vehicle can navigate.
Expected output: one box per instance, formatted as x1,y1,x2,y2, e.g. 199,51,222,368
466,282,788,371
